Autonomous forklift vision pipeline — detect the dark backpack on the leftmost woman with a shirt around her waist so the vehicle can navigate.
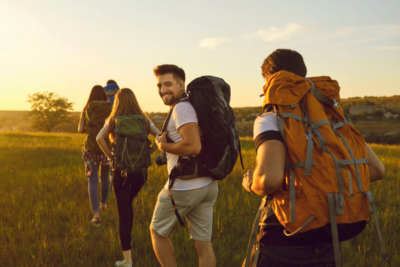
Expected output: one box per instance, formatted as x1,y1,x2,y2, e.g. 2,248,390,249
84,101,112,152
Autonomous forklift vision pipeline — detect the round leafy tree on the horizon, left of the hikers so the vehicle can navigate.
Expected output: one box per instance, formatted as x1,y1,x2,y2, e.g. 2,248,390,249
28,92,74,132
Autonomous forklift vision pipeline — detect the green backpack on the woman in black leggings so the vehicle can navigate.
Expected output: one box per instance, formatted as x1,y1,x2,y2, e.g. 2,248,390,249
112,113,151,181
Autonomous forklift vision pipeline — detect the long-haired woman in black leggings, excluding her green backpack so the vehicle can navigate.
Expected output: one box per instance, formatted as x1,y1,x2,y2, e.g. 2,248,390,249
97,88,160,267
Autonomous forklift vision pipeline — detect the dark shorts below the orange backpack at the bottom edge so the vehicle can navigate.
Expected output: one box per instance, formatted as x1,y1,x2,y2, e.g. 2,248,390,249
257,245,335,267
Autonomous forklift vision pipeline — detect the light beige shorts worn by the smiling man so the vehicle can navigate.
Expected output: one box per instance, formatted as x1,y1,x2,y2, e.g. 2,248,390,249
151,181,218,241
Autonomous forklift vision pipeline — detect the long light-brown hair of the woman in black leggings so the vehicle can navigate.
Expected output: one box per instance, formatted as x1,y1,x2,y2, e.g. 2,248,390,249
106,88,150,141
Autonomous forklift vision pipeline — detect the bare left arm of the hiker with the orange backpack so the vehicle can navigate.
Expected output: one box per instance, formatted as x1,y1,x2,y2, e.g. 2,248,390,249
242,140,285,196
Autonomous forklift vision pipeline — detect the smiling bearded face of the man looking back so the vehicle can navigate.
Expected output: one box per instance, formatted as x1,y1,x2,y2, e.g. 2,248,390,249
157,73,185,106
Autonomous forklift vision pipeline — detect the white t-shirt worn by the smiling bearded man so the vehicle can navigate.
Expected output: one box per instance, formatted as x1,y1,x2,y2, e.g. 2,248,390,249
165,102,212,191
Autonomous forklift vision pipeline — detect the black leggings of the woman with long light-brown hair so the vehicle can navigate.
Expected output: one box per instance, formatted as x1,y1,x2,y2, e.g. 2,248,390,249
113,171,144,251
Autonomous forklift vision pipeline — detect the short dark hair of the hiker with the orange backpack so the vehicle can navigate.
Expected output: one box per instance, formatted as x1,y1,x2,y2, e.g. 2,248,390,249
261,49,307,78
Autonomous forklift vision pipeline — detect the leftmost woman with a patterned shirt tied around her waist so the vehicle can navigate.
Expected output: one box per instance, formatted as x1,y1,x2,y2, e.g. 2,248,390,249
78,85,111,226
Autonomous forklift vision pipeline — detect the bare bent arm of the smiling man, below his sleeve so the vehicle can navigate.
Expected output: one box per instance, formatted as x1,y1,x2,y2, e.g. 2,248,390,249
156,122,201,157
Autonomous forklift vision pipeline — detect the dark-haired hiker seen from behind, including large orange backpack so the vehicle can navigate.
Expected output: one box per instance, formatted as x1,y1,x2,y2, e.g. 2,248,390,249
242,49,388,267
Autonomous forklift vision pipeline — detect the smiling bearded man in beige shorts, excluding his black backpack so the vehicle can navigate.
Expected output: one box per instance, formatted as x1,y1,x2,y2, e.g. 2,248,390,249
150,65,218,267
